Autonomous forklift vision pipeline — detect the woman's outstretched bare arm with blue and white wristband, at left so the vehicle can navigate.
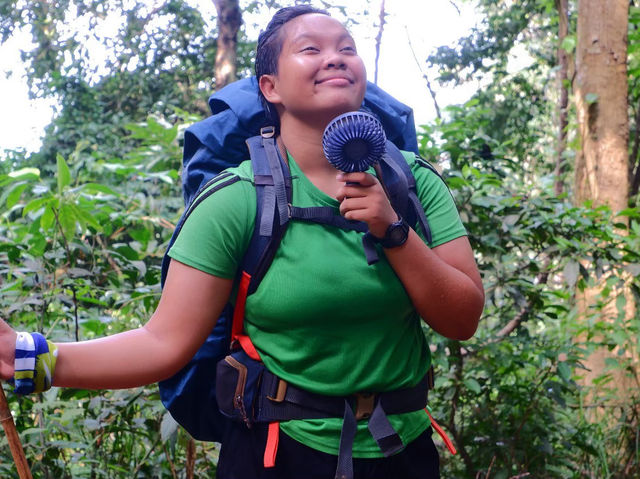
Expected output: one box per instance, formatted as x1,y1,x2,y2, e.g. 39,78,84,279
0,260,232,389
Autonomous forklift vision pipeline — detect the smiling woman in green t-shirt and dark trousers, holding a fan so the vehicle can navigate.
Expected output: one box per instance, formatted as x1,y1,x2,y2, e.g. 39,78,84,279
0,6,484,479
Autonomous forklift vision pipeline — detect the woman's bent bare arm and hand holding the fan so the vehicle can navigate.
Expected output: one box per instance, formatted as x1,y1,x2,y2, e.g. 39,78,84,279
337,172,484,340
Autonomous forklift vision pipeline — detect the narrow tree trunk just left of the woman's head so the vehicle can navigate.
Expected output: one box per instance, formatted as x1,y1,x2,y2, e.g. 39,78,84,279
213,0,242,90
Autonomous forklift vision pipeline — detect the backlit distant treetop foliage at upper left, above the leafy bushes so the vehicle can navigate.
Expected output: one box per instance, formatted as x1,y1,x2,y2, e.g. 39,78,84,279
0,0,216,168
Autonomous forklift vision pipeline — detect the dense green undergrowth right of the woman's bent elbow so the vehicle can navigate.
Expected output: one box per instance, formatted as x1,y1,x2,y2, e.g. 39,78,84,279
421,101,640,478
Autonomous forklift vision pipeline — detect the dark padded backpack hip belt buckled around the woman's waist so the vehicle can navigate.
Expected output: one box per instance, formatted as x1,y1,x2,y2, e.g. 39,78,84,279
216,349,432,479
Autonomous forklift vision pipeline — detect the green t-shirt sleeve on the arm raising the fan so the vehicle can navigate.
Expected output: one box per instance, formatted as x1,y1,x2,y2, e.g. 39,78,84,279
404,153,467,248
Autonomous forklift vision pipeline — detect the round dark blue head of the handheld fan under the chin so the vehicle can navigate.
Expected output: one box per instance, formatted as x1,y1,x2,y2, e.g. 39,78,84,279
322,111,387,173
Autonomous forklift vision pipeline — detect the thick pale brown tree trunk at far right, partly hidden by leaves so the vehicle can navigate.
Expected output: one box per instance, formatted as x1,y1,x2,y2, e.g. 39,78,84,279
574,0,633,402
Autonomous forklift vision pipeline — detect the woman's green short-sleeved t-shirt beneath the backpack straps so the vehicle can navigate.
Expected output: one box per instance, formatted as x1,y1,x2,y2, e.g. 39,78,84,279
169,153,466,457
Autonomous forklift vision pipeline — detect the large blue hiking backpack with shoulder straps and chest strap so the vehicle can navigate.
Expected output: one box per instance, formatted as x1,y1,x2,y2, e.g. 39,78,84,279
159,77,431,442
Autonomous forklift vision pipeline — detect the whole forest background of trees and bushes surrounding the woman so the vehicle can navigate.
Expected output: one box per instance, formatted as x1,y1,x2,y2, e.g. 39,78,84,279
0,0,640,479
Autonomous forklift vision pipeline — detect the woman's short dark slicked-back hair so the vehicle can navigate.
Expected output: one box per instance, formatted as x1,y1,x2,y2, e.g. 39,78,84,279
255,5,329,127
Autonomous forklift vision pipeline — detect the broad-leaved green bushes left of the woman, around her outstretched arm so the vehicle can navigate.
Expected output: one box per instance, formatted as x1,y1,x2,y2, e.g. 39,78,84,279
0,111,198,478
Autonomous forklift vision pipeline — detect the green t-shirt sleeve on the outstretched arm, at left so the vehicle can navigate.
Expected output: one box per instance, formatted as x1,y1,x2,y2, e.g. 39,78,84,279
169,177,256,279
